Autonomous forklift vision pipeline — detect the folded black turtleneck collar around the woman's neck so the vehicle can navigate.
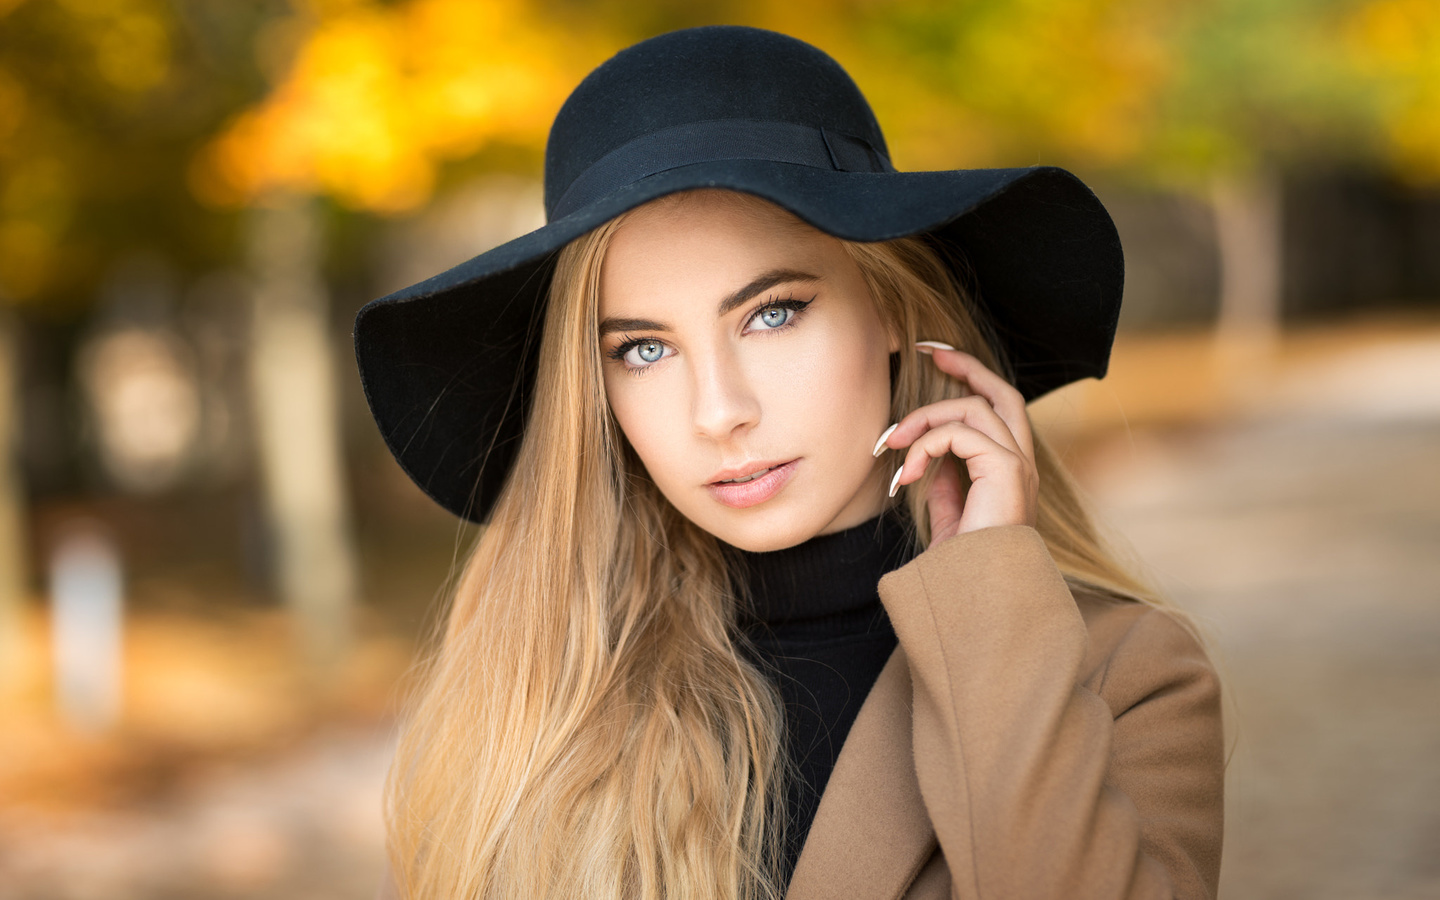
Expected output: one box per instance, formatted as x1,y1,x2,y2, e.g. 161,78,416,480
730,511,913,629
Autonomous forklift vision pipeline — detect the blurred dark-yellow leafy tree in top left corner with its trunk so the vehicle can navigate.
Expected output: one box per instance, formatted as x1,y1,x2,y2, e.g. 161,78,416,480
0,0,278,688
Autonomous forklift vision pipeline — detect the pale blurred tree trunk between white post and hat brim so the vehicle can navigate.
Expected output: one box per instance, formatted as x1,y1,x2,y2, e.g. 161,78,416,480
251,197,357,672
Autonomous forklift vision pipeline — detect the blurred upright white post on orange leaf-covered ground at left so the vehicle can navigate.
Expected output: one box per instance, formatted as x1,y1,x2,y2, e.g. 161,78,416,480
50,527,124,732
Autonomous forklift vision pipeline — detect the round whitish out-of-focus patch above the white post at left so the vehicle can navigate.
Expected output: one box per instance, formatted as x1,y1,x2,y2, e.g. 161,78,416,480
81,327,200,492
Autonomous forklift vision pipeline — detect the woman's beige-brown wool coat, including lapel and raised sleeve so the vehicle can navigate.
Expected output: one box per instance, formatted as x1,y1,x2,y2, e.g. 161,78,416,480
786,526,1224,900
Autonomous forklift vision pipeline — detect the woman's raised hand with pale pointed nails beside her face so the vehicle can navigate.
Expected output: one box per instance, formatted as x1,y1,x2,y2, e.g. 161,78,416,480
877,341,1040,546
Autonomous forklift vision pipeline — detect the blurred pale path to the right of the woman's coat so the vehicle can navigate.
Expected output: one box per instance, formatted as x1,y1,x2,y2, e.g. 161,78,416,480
1086,388,1440,900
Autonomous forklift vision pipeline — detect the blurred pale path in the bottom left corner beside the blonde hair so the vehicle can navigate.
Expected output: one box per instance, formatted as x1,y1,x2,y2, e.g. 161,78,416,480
0,732,390,900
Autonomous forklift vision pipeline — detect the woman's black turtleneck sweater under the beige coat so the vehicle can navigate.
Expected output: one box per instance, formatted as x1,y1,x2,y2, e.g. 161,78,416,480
732,513,913,880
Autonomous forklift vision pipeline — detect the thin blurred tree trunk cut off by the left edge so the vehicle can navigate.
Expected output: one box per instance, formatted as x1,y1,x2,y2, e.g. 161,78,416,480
0,311,27,694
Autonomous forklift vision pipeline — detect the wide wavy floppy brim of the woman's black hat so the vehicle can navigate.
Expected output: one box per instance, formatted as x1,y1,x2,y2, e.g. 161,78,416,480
354,160,1125,521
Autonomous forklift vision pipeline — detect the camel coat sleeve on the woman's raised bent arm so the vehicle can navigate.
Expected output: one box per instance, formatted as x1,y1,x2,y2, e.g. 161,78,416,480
880,526,1224,900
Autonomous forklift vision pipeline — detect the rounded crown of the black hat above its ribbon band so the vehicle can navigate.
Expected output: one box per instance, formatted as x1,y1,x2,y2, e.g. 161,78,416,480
544,26,887,217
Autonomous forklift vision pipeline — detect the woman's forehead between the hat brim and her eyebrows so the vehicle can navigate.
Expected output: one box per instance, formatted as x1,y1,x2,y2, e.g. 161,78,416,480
600,190,848,312
